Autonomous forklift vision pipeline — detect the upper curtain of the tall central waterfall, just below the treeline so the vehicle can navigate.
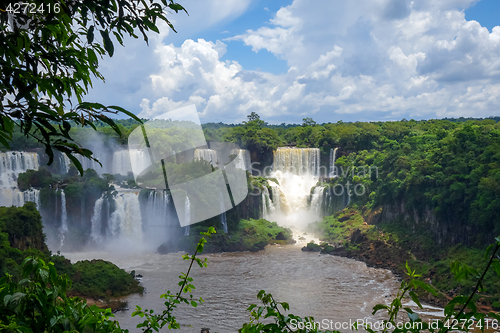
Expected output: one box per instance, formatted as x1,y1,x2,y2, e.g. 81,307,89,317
273,147,320,177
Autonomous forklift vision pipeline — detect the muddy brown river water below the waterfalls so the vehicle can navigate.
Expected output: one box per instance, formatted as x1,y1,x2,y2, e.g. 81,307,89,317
64,235,454,333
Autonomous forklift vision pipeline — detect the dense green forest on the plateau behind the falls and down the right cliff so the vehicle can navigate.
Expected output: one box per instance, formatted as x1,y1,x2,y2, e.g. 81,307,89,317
5,113,500,244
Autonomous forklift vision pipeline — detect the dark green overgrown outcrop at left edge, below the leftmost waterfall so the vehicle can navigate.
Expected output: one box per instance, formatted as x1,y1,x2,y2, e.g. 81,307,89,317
0,202,48,253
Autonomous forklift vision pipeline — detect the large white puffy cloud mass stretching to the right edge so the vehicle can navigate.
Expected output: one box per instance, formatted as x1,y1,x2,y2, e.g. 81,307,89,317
140,0,500,122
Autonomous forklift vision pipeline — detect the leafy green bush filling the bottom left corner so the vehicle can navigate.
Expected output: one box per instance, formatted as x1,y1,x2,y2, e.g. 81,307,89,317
0,258,121,333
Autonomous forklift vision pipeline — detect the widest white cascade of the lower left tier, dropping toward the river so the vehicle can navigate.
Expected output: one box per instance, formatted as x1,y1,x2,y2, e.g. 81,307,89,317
109,192,142,241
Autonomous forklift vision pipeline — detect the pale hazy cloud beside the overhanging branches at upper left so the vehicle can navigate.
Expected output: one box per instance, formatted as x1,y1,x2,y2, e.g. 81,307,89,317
83,0,250,112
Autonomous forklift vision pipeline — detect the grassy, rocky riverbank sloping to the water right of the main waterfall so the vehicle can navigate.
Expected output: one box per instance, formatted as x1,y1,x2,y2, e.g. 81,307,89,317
309,208,500,312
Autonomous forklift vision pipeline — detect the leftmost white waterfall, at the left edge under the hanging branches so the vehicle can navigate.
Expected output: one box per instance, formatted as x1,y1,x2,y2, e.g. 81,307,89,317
0,151,40,209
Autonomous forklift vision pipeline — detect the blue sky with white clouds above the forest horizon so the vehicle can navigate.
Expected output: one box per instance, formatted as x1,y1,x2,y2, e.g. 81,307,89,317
87,0,500,124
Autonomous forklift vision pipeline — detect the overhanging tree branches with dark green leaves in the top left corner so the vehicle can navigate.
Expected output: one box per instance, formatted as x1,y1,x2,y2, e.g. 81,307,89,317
0,0,185,174
